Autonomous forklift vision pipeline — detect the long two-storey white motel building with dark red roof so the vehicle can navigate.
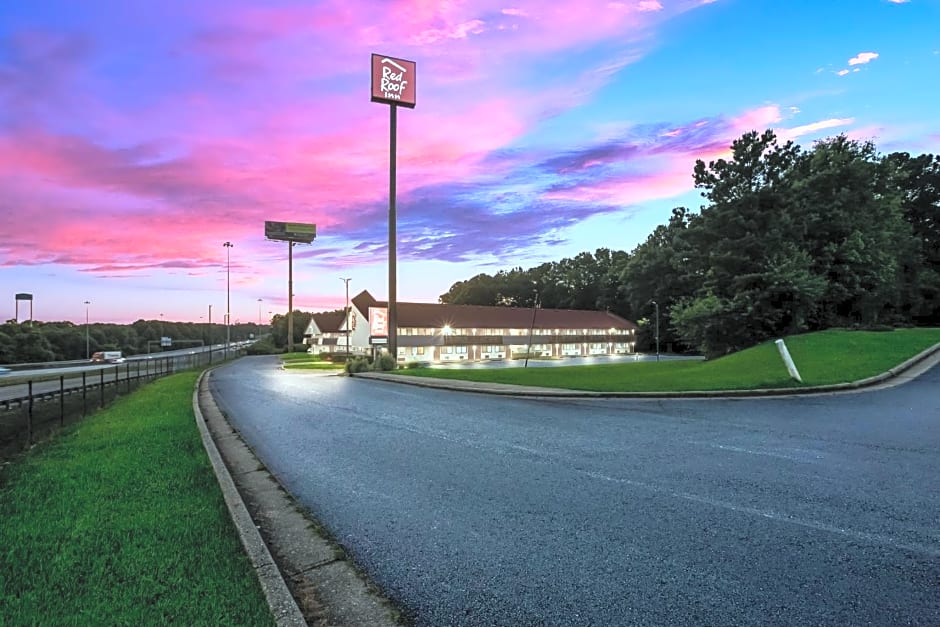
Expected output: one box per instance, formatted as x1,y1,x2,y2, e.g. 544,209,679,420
304,291,637,363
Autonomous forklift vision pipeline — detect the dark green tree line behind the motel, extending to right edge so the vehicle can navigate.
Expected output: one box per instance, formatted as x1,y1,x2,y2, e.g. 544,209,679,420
440,130,940,356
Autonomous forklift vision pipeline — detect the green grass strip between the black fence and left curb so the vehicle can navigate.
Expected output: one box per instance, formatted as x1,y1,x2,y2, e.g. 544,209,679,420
0,372,274,625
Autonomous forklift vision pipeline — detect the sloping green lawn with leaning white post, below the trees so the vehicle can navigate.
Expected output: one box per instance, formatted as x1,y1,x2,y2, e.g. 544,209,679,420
395,329,940,392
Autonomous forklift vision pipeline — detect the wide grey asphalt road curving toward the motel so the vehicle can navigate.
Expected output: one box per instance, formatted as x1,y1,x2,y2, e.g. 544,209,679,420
211,357,940,626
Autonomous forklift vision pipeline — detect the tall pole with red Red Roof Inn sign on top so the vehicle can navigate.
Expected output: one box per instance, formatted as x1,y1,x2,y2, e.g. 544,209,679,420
372,54,417,363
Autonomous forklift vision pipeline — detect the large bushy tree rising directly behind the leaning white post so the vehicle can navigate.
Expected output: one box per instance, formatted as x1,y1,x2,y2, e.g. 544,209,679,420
669,130,819,354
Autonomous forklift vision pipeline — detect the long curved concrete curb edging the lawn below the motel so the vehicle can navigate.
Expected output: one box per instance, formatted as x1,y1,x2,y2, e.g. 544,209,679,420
349,343,940,399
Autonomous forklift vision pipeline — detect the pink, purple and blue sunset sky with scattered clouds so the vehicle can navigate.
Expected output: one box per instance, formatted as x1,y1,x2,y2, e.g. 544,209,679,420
0,0,940,323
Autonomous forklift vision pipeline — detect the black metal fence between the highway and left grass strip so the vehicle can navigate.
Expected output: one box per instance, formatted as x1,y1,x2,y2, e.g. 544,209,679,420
0,350,239,458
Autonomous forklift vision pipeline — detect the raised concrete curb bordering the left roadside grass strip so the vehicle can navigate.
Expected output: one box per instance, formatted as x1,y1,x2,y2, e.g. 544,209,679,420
193,370,307,627
